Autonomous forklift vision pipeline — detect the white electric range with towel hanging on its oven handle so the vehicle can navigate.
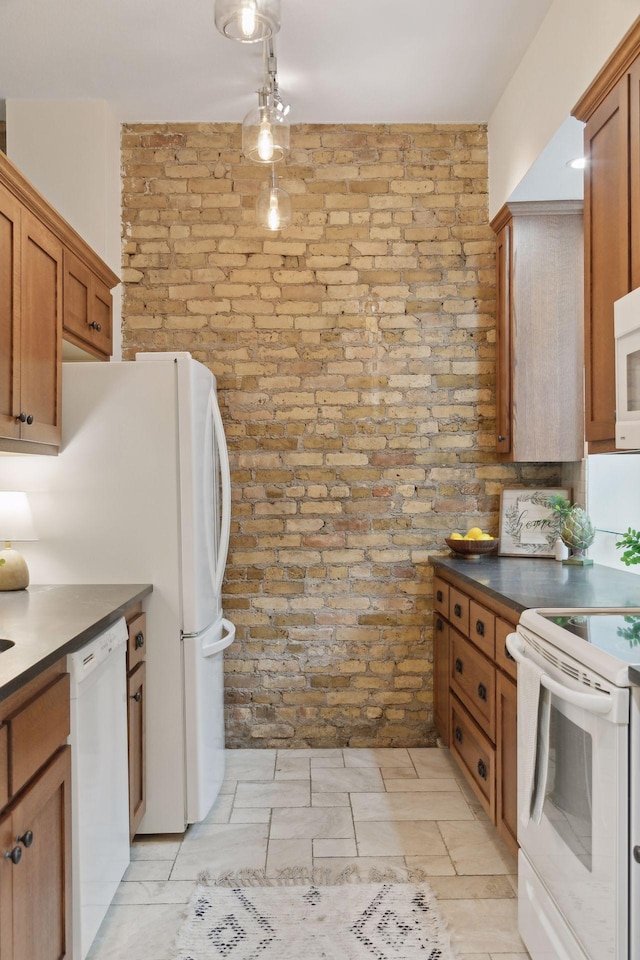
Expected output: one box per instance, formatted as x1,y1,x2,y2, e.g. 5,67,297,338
507,607,640,960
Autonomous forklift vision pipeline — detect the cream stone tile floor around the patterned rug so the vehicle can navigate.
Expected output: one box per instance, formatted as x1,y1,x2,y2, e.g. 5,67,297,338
88,748,528,960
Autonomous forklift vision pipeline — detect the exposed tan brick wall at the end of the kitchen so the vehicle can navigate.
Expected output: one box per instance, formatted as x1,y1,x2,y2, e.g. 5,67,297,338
122,124,559,746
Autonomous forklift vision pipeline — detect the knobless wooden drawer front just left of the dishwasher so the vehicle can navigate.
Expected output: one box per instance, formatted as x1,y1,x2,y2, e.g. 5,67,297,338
7,673,70,797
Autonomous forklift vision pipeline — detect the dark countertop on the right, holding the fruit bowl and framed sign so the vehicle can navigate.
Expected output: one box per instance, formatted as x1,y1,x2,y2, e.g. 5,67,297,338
430,554,640,613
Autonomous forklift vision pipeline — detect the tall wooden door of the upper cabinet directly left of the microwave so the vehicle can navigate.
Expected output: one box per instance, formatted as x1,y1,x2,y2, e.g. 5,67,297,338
584,75,631,453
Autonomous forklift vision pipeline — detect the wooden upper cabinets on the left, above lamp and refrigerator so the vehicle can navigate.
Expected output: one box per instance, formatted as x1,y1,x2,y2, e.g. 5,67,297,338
0,154,118,453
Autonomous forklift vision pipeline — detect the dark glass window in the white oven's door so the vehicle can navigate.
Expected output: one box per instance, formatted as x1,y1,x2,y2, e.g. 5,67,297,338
542,703,593,872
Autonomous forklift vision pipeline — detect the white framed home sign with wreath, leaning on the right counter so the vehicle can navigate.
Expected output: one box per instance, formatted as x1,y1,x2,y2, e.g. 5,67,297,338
498,487,571,557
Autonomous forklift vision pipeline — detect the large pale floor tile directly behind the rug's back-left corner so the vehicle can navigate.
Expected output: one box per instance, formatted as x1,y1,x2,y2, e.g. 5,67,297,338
171,823,269,880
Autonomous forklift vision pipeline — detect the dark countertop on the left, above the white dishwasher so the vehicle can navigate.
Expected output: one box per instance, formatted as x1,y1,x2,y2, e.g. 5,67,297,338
0,583,153,700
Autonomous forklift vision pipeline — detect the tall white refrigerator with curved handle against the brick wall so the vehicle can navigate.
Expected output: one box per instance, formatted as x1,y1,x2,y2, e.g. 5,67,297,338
0,353,235,833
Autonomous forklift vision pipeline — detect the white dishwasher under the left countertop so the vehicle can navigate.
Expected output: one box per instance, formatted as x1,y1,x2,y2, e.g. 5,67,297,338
67,618,130,960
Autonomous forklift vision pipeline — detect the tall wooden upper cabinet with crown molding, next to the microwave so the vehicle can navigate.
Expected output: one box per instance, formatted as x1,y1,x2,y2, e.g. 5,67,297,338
572,18,640,453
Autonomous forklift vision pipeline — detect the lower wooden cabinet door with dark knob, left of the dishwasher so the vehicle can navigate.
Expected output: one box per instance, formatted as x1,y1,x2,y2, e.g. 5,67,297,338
0,747,71,960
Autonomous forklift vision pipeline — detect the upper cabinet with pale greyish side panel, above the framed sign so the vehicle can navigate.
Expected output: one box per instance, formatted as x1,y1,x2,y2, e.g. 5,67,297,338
491,200,584,462
